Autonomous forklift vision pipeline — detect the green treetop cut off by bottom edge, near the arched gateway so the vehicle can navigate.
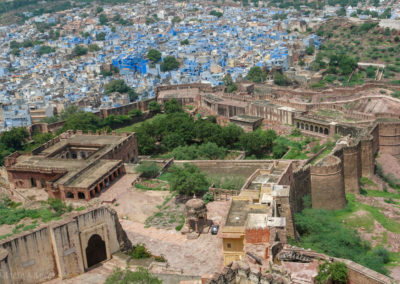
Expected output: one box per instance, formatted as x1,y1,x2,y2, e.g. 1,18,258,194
104,267,162,284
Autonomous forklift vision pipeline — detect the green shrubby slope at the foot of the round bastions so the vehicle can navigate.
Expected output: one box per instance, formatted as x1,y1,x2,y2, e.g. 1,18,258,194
291,196,390,274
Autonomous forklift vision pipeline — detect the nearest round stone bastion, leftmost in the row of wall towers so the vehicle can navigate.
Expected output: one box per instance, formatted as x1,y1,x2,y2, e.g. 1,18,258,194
310,155,346,210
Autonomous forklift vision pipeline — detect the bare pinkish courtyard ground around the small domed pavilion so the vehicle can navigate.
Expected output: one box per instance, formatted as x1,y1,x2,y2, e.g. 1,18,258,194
48,172,230,284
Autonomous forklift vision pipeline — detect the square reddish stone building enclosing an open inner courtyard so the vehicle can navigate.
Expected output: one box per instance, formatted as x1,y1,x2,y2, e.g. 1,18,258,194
5,131,138,200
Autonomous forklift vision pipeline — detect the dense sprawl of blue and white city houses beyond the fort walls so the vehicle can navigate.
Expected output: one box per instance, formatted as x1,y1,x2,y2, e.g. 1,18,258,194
0,1,323,131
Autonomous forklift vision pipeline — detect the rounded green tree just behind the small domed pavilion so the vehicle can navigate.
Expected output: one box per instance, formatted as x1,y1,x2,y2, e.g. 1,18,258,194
169,163,209,196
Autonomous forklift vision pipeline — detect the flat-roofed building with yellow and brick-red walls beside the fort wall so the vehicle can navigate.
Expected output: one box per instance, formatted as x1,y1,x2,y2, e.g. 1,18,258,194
221,161,295,265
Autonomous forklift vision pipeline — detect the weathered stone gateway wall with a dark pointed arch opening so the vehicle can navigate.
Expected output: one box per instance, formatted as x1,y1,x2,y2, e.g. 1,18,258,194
0,206,132,284
